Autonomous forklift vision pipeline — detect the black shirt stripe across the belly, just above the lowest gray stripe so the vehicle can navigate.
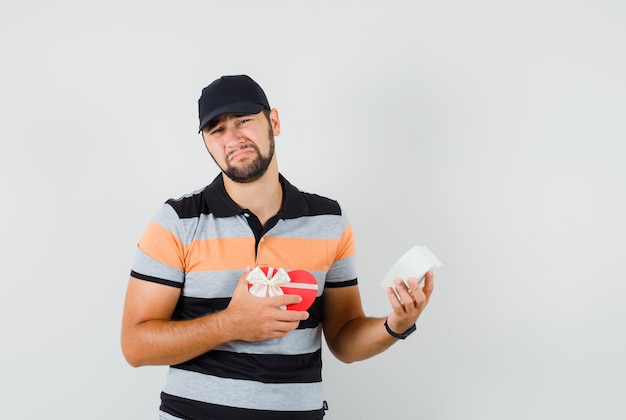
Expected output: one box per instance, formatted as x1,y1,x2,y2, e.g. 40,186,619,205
172,349,322,384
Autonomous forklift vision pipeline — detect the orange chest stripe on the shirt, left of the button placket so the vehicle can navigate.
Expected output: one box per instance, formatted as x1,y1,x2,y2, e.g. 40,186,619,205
185,237,255,272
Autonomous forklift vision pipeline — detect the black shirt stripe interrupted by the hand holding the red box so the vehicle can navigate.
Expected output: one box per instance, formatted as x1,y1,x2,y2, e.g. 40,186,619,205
172,295,324,329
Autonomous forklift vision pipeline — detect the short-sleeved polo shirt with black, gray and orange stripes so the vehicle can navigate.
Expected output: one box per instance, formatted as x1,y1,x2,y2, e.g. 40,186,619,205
131,174,357,420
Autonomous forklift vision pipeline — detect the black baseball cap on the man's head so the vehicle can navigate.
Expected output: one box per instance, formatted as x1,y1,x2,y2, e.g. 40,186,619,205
198,74,270,132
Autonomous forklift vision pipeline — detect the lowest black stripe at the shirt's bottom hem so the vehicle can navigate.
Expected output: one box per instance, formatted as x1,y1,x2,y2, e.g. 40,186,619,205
160,392,324,420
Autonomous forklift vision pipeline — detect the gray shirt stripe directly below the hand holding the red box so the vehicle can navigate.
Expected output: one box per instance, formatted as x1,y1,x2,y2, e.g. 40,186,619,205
216,325,322,355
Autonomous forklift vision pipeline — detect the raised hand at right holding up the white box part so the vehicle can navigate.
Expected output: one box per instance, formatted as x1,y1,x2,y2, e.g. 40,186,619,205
387,271,435,334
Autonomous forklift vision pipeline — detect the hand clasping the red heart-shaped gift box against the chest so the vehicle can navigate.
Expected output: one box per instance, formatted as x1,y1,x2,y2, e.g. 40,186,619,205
223,269,309,341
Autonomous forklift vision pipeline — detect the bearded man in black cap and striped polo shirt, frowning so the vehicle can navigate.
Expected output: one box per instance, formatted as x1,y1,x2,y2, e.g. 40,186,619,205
122,75,433,420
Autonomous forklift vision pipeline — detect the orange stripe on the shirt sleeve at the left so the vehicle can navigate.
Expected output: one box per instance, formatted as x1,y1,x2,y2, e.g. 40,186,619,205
138,222,185,270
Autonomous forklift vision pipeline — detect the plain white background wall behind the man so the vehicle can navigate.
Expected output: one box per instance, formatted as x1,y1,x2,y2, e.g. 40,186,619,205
0,0,626,420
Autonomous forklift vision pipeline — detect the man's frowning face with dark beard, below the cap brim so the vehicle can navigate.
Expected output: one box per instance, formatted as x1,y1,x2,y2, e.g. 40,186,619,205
202,110,280,183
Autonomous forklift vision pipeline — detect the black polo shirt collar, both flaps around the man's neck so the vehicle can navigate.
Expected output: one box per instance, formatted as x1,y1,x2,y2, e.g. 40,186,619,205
204,173,307,219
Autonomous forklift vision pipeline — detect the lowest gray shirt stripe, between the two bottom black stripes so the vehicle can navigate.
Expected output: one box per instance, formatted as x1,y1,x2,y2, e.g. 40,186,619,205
163,368,324,411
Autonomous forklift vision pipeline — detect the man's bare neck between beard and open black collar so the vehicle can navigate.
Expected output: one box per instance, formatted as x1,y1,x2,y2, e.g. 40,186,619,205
224,158,283,225
